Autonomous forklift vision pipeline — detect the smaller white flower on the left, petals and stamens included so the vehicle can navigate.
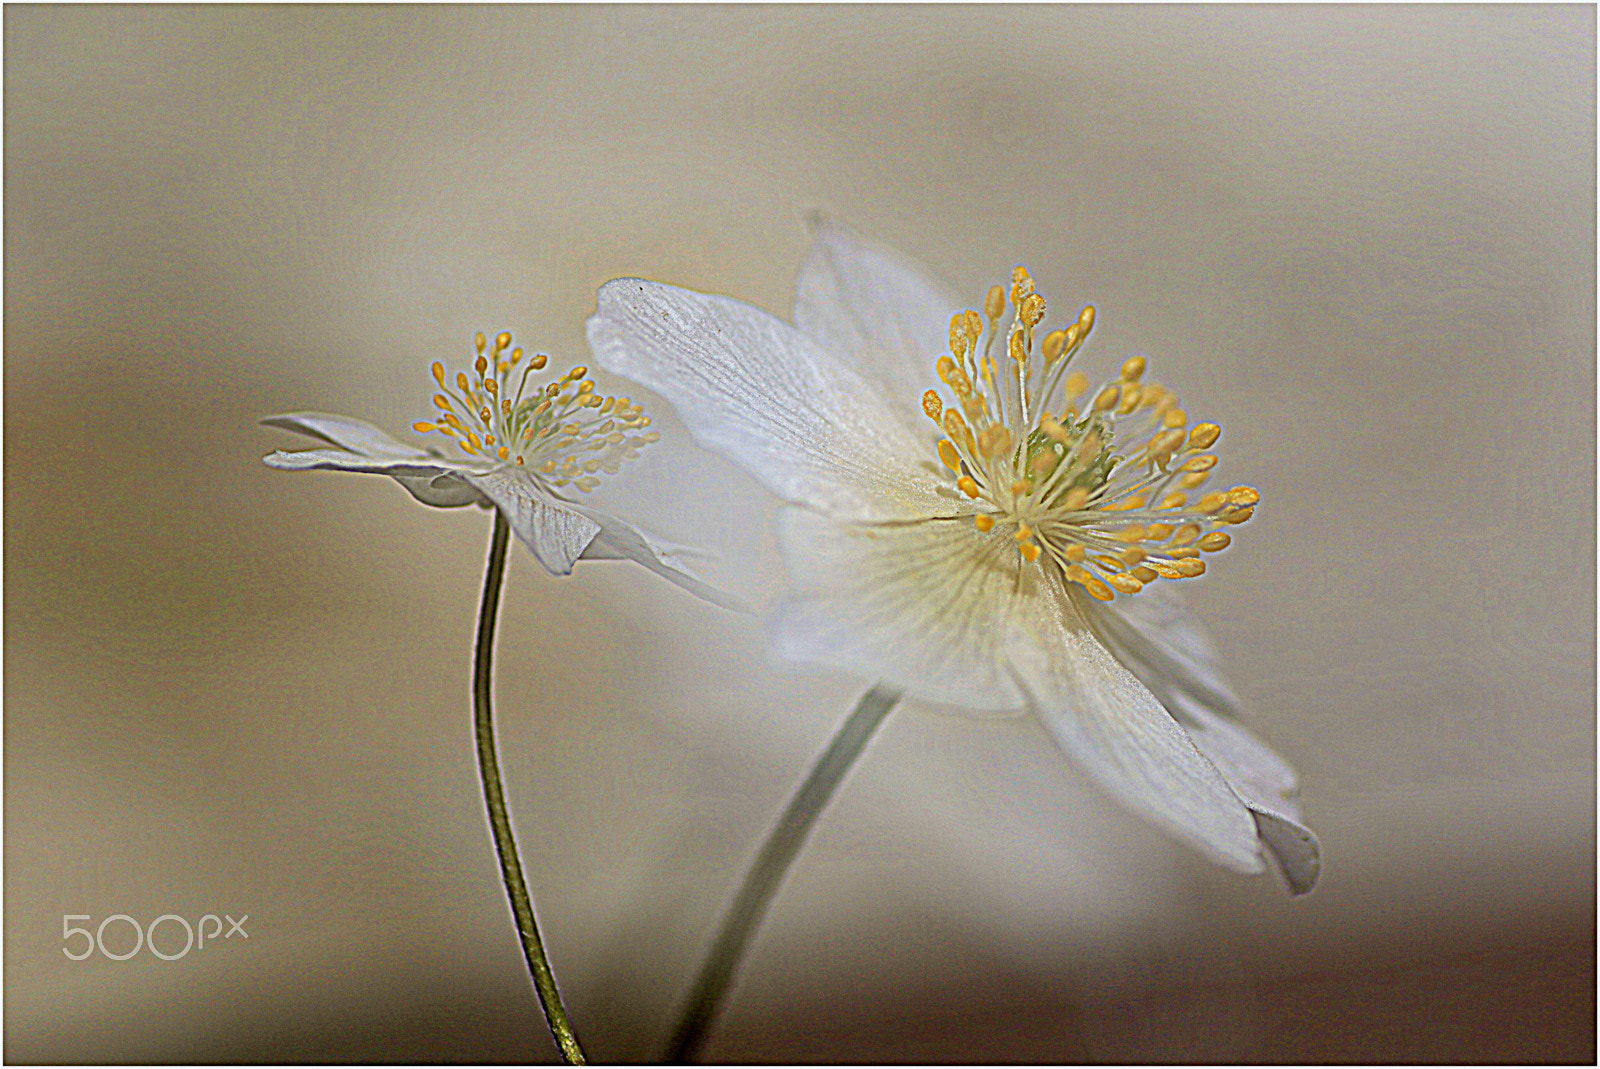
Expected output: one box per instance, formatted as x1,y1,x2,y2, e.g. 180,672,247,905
262,326,731,605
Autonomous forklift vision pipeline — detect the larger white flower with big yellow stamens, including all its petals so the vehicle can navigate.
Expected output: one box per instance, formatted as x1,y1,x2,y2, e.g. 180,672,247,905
589,224,1318,893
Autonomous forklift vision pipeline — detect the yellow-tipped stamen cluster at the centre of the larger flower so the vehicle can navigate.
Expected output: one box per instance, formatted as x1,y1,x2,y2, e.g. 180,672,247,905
922,267,1261,602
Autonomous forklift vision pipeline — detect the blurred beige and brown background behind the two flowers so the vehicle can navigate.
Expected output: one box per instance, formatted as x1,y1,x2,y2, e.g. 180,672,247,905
5,5,1595,1061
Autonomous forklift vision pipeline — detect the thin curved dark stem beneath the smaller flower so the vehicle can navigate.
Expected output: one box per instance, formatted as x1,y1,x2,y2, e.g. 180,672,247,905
472,509,584,1066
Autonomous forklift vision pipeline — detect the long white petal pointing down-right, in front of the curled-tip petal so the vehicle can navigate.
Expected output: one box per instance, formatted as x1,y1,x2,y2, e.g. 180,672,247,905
1006,583,1264,872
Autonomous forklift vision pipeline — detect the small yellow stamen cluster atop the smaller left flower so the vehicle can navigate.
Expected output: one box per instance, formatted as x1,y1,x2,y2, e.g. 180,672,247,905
413,334,661,491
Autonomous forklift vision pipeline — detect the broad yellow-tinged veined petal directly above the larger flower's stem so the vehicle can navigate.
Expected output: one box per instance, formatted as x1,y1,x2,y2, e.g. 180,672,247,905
773,509,1030,711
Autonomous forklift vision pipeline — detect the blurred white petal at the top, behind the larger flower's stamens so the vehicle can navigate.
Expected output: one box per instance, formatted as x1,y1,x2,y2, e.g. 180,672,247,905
795,219,966,412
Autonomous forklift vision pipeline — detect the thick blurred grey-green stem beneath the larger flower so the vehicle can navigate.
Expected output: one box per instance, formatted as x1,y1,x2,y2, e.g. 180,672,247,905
662,683,901,1063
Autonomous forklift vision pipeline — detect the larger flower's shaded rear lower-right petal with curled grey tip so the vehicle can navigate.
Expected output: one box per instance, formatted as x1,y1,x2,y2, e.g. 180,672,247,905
1074,584,1320,895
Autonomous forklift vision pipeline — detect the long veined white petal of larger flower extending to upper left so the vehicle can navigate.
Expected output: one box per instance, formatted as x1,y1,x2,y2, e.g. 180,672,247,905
589,278,944,517
